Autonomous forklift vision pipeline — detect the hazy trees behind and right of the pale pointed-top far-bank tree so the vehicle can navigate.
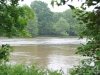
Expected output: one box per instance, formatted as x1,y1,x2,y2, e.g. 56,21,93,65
52,9,82,36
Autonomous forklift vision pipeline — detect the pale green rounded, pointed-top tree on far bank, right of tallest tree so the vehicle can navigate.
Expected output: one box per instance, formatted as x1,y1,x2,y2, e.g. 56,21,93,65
53,17,69,36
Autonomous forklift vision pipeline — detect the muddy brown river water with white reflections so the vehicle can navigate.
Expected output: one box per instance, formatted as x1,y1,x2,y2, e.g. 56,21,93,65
0,38,86,72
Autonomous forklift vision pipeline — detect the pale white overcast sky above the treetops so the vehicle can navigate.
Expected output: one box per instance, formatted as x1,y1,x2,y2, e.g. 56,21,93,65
20,0,81,12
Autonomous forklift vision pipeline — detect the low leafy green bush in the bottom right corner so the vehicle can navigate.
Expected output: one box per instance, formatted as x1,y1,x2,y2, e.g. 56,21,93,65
69,59,100,75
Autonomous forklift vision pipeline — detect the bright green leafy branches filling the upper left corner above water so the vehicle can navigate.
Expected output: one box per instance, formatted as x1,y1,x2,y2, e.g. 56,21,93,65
0,0,34,37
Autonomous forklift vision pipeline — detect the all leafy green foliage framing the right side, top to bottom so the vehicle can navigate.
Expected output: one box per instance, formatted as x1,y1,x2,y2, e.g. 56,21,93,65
51,0,100,75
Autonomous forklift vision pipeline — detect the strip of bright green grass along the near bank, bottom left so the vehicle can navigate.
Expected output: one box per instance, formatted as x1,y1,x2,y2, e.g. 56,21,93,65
0,64,63,75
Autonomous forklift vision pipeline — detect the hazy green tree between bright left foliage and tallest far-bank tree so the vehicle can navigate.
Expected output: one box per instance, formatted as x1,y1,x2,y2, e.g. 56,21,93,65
26,15,38,37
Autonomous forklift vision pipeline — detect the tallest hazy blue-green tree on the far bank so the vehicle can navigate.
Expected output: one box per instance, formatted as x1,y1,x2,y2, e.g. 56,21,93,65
30,1,53,35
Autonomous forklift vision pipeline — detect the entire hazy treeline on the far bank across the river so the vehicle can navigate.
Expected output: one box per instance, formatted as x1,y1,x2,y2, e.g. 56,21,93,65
26,1,80,37
